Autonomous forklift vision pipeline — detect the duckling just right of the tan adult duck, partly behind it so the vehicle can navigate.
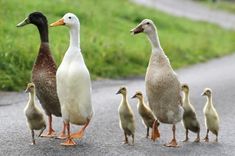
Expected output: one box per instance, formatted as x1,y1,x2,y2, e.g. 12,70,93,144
182,84,200,142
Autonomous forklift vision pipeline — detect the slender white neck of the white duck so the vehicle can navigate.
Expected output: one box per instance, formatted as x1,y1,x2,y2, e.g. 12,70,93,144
69,25,80,48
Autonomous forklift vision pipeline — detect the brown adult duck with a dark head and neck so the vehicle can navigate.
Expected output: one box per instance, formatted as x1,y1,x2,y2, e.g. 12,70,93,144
17,12,65,138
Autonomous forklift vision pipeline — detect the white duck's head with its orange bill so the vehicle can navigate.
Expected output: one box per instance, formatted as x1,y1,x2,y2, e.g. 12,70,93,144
50,13,80,27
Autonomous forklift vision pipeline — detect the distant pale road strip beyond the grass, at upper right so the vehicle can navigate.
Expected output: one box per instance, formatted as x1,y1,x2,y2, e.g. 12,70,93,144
132,0,235,29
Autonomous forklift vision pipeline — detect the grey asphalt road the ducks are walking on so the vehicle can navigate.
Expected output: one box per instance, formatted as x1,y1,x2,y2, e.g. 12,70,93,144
0,55,235,156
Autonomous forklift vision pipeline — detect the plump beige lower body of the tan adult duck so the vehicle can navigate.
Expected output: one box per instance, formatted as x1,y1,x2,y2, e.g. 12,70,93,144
145,67,183,123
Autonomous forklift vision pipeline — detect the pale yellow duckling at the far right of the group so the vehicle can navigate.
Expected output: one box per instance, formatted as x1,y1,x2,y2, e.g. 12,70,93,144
202,88,220,142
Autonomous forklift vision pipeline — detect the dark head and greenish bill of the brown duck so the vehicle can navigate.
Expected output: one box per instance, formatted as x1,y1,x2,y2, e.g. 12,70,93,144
16,12,47,27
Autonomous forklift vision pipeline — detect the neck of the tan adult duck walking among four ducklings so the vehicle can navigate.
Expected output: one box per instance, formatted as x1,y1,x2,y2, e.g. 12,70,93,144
147,30,162,52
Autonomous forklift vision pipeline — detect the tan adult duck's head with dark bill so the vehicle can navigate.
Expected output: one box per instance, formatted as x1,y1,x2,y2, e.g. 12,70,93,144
131,19,156,35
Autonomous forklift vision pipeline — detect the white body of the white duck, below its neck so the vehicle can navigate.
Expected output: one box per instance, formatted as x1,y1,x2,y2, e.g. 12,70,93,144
57,51,93,125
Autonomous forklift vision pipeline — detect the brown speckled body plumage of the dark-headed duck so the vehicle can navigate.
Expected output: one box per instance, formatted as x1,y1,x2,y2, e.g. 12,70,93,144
32,42,61,116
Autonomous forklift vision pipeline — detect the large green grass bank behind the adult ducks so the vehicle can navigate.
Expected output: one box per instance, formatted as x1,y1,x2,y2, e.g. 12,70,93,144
0,0,235,90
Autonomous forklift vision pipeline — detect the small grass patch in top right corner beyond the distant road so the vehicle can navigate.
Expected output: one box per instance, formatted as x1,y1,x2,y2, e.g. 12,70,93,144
202,0,235,13
